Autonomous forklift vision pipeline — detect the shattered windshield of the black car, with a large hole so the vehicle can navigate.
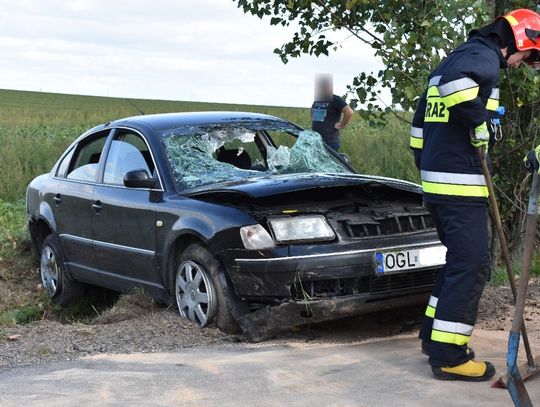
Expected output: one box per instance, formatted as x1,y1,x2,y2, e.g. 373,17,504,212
162,122,351,189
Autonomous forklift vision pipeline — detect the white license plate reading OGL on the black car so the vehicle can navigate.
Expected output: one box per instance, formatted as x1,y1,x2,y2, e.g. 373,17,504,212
375,245,446,274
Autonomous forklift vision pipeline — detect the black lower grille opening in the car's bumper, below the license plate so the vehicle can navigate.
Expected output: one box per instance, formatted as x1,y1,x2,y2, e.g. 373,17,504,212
291,269,439,300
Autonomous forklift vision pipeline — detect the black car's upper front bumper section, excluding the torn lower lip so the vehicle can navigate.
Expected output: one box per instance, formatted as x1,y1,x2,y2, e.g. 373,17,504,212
225,239,441,302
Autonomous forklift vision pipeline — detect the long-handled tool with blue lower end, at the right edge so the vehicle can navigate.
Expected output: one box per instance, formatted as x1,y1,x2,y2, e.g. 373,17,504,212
506,171,540,407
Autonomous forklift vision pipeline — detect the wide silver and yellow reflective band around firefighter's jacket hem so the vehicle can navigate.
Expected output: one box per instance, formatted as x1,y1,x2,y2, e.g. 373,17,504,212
421,170,489,198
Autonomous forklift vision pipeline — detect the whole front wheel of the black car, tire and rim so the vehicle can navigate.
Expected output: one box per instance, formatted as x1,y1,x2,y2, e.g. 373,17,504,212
174,243,240,334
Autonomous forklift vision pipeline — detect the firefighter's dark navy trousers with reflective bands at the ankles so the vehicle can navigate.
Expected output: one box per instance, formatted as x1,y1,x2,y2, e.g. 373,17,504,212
419,204,490,367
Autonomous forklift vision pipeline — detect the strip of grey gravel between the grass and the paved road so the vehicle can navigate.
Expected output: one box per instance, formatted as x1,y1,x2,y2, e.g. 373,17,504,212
0,310,238,368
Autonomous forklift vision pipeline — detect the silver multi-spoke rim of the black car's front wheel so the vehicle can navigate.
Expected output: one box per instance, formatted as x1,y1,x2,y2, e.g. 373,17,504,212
175,261,216,327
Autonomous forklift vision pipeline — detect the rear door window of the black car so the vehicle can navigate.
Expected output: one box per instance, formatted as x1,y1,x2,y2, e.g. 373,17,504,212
67,131,109,182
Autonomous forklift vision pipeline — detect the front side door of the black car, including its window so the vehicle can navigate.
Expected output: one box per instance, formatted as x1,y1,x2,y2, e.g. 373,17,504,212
91,129,161,290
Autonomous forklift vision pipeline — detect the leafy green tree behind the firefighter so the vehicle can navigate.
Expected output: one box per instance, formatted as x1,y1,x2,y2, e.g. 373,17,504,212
235,0,539,260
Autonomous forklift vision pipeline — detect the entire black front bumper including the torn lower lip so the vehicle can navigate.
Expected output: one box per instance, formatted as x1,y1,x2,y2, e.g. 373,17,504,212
219,234,442,341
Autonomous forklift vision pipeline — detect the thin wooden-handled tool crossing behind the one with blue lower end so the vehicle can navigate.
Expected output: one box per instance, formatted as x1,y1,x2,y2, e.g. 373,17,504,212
478,148,540,380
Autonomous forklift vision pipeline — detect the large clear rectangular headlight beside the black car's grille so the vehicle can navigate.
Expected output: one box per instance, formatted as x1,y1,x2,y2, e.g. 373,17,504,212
268,215,336,243
